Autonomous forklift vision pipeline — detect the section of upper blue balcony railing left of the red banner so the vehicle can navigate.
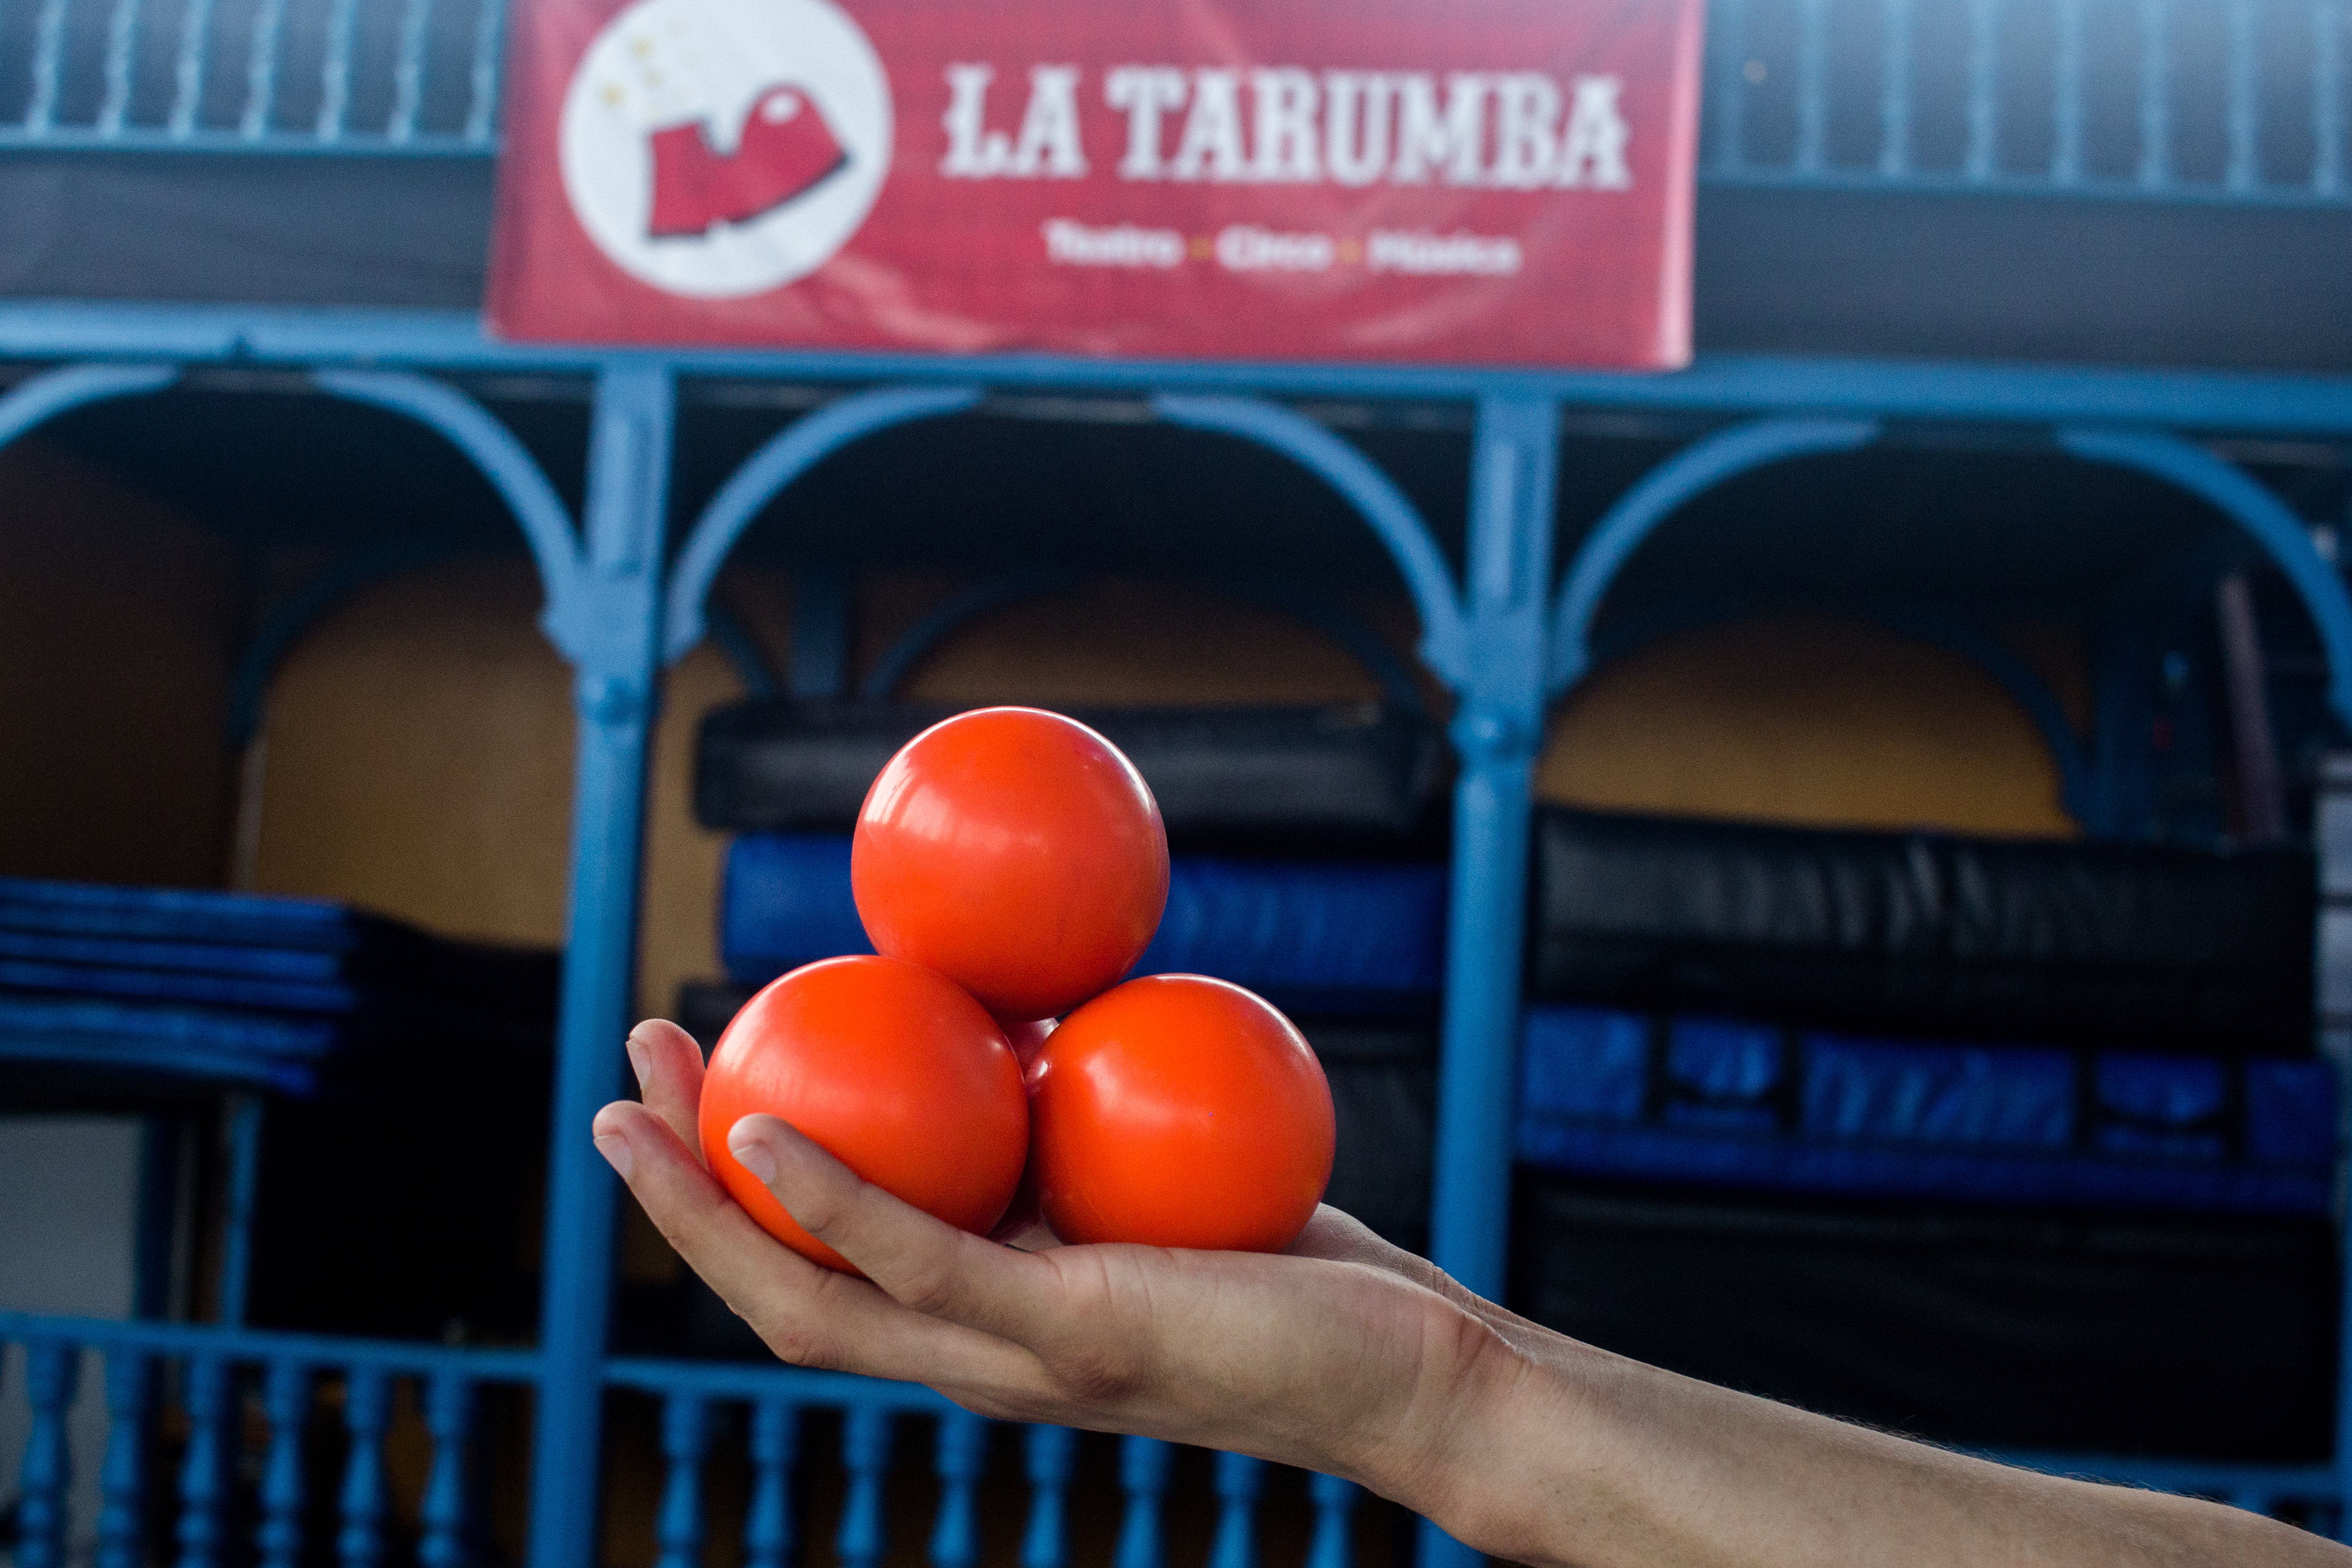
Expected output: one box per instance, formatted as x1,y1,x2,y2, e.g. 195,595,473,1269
0,0,506,155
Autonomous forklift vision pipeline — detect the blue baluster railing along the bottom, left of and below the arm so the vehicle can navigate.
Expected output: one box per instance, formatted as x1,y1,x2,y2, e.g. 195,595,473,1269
0,1312,1359,1568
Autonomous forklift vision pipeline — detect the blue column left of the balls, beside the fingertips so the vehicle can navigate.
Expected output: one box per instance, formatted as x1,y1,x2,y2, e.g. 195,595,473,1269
529,362,672,1568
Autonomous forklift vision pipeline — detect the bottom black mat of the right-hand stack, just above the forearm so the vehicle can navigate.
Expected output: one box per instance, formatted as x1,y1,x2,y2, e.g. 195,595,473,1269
1508,1175,2335,1460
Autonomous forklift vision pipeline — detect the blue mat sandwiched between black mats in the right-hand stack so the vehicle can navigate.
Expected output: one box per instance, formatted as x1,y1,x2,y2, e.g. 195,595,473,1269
1517,1006,2335,1215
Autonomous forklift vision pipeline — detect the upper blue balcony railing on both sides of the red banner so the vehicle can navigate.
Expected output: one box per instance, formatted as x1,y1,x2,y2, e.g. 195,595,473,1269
0,0,2352,204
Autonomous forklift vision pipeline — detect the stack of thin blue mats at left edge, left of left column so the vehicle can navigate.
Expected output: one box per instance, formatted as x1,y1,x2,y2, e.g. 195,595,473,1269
0,879,557,1098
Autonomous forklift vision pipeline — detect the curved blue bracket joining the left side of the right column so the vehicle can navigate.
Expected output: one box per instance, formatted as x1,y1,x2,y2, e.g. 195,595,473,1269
1152,395,1470,691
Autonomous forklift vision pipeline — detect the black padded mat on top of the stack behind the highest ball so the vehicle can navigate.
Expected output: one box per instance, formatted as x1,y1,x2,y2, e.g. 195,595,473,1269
694,698,1444,849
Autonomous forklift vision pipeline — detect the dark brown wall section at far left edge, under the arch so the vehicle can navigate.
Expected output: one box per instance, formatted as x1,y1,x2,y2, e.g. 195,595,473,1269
0,440,240,886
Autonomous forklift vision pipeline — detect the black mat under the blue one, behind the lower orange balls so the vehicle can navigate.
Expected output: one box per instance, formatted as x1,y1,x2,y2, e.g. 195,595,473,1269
677,983,1437,1253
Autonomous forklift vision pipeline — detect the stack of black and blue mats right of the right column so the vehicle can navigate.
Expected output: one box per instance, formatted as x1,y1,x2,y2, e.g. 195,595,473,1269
1515,811,2335,1458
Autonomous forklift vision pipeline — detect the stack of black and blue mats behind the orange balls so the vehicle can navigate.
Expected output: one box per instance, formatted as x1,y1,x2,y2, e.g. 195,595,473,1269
680,701,1446,1246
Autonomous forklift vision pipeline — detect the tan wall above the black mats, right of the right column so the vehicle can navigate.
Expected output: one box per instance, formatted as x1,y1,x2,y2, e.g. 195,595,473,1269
1536,616,2086,835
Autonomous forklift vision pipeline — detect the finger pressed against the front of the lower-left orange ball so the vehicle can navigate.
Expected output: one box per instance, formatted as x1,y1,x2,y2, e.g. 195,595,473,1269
727,1116,1056,1345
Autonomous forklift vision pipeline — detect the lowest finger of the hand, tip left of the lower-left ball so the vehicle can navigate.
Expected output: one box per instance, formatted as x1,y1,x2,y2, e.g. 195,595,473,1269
595,1100,1037,1387
